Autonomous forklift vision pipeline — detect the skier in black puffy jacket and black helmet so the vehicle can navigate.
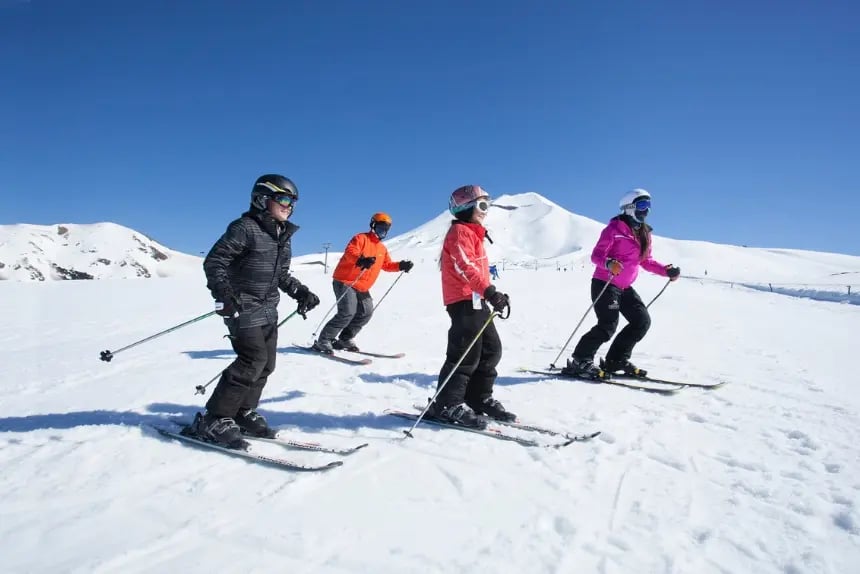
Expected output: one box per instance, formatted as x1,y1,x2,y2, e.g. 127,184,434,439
190,174,319,448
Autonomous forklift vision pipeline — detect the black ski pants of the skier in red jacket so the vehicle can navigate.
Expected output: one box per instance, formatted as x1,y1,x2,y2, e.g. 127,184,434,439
436,299,502,407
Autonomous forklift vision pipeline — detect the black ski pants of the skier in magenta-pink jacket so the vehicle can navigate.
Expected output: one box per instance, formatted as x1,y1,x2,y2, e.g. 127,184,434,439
573,279,651,362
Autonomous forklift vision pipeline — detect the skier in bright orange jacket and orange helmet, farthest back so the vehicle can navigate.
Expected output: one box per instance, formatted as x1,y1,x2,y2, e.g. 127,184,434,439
313,213,412,354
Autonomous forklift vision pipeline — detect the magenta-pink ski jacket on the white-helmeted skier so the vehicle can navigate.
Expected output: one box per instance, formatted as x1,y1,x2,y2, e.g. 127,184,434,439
591,216,667,289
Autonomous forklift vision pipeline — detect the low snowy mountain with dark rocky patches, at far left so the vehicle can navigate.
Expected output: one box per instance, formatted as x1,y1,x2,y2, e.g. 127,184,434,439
0,223,201,281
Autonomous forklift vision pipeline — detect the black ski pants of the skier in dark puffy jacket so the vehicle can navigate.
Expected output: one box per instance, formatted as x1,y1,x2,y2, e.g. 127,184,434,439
206,319,278,418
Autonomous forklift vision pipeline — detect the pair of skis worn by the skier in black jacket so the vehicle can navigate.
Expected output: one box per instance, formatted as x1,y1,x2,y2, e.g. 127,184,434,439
153,421,367,472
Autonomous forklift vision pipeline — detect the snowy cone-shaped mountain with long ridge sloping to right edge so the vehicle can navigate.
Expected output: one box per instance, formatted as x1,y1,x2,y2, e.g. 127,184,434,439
295,192,860,288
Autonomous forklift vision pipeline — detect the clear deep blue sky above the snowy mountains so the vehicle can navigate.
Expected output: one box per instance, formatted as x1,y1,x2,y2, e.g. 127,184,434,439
0,0,860,254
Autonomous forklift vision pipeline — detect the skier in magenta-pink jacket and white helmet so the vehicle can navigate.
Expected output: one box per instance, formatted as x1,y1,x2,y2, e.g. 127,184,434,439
561,189,681,380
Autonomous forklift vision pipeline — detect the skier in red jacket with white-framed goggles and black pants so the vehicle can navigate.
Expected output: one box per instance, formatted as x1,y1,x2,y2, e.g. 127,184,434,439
427,185,516,428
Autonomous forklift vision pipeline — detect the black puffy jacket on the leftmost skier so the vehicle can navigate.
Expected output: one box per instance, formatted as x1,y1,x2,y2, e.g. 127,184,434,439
203,209,303,328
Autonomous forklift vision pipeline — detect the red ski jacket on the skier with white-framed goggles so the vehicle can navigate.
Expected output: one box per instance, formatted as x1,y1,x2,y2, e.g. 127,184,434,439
439,222,490,305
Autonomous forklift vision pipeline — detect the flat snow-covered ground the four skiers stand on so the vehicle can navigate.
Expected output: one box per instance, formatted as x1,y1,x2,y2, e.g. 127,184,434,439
0,264,860,574
